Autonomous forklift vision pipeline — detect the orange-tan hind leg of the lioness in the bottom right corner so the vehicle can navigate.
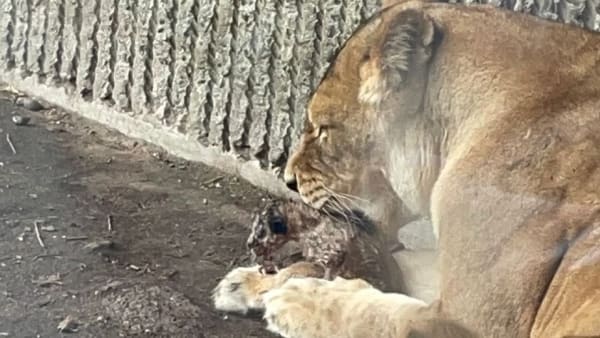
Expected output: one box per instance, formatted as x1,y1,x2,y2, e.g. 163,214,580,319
531,225,600,338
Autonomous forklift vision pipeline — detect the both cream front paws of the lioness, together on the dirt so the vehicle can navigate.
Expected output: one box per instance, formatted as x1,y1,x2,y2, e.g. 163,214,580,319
213,263,476,338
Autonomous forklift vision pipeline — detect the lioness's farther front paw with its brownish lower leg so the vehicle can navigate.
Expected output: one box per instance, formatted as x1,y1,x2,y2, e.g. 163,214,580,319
212,262,323,314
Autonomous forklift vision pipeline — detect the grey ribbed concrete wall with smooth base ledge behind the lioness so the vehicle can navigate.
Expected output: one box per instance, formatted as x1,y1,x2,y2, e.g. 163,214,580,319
0,0,600,195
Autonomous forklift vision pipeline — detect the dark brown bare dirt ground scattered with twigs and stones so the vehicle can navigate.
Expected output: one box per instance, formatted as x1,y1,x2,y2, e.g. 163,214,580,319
0,94,274,338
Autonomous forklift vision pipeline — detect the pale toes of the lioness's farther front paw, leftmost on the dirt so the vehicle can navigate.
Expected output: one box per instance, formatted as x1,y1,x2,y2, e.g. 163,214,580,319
212,265,265,314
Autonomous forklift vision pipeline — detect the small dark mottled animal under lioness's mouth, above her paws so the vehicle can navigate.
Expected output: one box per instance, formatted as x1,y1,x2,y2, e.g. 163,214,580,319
247,200,403,292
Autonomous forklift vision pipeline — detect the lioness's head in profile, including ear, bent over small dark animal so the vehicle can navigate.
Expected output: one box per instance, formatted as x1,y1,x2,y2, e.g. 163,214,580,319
284,2,438,209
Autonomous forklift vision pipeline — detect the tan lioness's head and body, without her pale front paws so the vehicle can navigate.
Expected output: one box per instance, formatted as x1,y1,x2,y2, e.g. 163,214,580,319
285,2,600,338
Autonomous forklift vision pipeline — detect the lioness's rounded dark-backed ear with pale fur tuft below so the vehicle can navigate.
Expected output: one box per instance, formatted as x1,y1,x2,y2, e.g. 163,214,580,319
359,9,439,104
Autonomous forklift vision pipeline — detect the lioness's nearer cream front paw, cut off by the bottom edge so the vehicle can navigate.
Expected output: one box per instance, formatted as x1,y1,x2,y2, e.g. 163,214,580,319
264,277,426,338
